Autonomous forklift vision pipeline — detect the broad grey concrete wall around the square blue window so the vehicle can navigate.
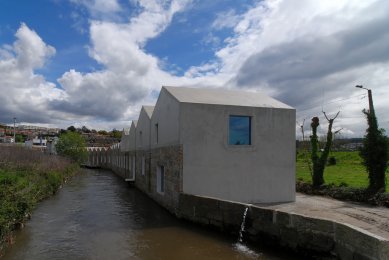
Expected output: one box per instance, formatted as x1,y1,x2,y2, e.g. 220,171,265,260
180,103,296,203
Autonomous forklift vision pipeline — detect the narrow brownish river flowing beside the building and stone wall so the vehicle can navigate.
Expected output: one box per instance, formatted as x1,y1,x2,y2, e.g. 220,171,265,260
4,170,290,260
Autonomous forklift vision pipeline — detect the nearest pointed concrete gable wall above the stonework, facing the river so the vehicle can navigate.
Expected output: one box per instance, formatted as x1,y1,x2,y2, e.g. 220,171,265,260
151,88,180,148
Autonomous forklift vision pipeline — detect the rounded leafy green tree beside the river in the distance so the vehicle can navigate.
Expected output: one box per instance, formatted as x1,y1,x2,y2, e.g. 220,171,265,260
55,131,88,163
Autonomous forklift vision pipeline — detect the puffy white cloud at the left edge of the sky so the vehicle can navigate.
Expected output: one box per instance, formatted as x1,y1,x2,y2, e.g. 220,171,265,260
0,23,63,122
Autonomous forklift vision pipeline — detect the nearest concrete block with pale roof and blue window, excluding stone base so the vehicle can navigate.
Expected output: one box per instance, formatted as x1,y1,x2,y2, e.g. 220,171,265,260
151,87,296,203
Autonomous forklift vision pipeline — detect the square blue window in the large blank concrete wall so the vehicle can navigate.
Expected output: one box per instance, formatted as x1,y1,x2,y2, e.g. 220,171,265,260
228,116,251,145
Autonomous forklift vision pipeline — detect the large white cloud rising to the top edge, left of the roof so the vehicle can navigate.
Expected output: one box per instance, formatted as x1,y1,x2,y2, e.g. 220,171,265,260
52,1,193,120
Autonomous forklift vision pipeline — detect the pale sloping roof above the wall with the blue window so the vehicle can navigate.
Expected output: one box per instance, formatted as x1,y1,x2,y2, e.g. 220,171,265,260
162,86,293,109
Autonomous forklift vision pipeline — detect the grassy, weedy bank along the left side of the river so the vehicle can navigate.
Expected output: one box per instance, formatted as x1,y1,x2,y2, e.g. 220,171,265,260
0,146,79,256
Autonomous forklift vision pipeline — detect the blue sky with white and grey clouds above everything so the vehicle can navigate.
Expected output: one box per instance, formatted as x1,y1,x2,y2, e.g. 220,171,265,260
0,0,389,137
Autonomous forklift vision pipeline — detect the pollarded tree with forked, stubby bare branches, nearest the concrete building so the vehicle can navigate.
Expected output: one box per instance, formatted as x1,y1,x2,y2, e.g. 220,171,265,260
310,112,340,187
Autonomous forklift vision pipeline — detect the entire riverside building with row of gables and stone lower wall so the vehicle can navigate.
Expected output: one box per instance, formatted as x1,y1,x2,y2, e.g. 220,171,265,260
92,87,296,210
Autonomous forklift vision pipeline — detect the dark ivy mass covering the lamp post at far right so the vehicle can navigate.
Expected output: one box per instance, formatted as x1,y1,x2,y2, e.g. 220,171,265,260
360,109,389,193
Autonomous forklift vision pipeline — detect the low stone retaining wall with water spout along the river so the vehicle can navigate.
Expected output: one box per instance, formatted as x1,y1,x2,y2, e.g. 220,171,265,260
177,194,389,260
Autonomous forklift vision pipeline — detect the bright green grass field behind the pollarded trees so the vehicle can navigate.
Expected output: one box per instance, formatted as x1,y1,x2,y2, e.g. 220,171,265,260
296,152,389,191
